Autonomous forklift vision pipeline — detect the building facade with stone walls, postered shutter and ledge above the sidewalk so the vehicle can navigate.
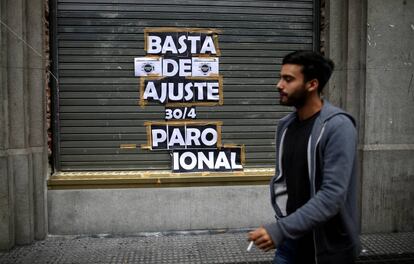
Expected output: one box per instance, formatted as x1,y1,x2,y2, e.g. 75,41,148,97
0,0,414,249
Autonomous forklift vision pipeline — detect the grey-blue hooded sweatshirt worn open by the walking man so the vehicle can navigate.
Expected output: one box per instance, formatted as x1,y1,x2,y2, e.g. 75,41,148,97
264,100,360,264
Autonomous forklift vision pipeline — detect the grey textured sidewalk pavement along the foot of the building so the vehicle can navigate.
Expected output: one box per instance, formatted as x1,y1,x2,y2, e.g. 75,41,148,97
0,230,414,264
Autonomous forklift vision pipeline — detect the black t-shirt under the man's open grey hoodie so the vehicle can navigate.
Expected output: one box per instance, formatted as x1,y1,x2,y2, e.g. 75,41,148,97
282,112,319,263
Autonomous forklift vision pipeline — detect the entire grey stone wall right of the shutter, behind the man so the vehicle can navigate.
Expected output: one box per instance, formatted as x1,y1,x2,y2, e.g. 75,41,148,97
326,0,414,233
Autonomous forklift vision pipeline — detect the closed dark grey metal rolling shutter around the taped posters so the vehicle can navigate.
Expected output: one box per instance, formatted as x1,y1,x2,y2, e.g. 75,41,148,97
54,0,318,171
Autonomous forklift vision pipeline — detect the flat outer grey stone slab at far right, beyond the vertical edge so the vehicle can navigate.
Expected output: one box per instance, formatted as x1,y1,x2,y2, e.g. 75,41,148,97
362,0,414,232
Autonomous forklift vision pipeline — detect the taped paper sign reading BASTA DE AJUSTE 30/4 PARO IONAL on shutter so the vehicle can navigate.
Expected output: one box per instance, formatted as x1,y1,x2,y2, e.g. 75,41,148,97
134,28,245,173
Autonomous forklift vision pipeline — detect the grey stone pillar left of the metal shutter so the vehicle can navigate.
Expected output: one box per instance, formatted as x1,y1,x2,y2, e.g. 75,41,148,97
0,0,47,249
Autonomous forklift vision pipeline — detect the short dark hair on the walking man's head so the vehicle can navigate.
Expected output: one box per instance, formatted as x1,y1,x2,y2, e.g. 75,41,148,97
282,51,334,93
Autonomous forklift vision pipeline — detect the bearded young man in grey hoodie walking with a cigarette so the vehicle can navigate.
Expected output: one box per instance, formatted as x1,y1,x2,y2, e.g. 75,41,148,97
249,51,360,264
